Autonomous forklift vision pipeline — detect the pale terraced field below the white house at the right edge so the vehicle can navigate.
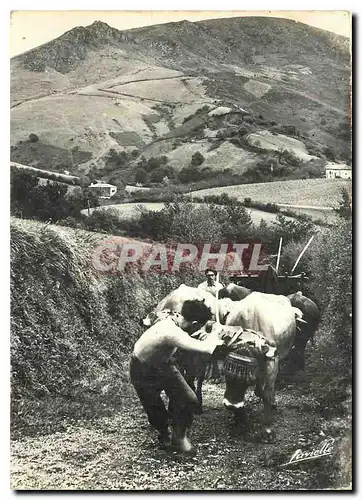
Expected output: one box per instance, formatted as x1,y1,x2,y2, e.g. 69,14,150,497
190,179,352,207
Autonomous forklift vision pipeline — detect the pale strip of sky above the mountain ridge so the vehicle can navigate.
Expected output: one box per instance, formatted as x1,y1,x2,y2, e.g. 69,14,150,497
10,10,351,57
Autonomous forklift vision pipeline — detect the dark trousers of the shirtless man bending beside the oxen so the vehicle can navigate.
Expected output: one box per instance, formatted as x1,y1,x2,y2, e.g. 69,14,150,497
130,356,198,432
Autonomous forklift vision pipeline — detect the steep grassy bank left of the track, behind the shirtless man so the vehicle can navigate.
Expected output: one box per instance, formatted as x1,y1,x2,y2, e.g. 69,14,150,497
11,219,206,434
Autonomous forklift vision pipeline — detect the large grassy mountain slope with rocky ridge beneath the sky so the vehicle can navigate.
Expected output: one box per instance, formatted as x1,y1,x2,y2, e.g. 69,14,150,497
11,17,350,184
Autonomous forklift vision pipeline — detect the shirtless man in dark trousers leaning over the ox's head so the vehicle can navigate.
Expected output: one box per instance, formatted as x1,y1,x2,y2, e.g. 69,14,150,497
130,300,222,453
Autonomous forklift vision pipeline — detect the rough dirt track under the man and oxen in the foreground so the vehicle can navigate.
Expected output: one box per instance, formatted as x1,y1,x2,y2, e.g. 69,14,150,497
11,384,350,491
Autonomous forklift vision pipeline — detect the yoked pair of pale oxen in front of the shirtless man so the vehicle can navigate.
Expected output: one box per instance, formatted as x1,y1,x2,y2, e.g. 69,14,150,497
143,284,320,442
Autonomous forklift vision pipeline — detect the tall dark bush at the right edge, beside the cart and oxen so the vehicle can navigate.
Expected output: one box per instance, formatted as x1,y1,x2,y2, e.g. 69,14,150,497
310,220,352,416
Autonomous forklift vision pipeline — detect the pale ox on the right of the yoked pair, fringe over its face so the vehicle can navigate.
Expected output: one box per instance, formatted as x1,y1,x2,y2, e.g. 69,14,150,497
218,292,302,441
